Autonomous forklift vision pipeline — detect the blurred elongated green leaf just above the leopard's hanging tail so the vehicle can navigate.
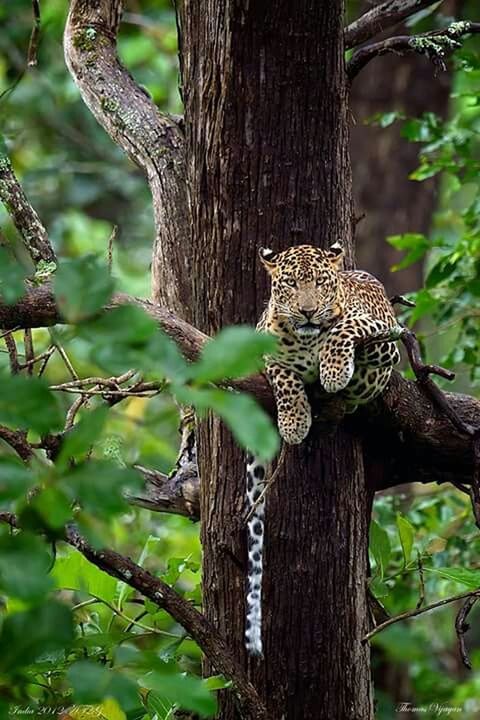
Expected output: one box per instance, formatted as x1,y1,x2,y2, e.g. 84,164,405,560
175,388,280,462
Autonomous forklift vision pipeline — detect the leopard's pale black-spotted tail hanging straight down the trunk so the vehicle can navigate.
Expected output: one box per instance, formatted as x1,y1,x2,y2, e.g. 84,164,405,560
245,455,265,656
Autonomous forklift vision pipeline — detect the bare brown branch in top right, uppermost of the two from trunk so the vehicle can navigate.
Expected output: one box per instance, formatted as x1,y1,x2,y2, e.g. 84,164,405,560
344,0,437,48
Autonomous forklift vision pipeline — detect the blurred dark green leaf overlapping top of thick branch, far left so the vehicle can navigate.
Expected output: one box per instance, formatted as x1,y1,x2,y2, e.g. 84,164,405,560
54,255,114,323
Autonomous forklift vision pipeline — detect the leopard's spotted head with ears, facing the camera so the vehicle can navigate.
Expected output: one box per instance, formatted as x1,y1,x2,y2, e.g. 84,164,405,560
259,243,343,335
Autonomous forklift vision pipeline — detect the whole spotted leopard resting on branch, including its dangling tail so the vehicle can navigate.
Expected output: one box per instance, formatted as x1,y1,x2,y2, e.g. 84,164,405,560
245,242,402,656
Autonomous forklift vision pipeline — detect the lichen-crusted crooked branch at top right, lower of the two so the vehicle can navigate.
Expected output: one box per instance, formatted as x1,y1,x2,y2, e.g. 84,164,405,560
347,20,480,80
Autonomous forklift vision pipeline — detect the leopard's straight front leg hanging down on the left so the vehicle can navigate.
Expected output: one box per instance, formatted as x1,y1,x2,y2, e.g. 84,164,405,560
266,363,312,445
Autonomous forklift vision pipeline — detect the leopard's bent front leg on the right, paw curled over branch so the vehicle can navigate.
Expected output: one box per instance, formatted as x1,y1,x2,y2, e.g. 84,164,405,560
319,316,391,393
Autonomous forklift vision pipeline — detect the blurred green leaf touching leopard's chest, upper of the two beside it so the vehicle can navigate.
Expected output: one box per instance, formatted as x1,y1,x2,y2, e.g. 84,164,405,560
193,325,277,383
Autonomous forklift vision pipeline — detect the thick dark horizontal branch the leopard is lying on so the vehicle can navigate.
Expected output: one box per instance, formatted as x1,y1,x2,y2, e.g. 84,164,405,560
0,286,480,490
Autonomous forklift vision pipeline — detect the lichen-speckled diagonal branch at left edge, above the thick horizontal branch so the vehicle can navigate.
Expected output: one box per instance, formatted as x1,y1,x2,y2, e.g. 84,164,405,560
0,145,55,263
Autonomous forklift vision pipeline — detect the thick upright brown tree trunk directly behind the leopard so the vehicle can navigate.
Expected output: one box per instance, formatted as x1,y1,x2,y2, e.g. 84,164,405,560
180,0,372,720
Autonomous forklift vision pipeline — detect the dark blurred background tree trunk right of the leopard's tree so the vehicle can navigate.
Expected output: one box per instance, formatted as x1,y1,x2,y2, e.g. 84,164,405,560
350,0,464,294
